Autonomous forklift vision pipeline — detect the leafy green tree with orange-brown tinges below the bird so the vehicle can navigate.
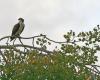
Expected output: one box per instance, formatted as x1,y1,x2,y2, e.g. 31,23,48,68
0,25,100,80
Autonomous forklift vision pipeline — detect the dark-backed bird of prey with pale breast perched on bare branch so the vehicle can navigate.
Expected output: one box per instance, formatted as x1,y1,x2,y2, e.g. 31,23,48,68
10,18,25,41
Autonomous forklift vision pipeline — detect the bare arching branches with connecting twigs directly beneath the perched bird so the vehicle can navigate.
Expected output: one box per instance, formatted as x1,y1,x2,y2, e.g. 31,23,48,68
0,34,66,53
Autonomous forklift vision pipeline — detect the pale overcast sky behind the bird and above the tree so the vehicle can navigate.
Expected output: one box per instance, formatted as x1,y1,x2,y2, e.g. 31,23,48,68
0,0,100,66
